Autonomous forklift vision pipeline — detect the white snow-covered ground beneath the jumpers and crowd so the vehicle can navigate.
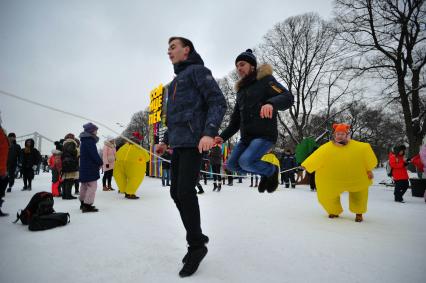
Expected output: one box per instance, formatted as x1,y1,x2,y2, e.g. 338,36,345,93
0,170,426,283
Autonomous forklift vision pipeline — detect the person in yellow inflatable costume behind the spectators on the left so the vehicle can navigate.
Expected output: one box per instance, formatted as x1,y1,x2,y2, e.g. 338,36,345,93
113,134,149,199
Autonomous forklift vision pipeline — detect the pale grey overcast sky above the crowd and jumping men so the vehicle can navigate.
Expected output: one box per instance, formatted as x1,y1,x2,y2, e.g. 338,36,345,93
0,0,332,153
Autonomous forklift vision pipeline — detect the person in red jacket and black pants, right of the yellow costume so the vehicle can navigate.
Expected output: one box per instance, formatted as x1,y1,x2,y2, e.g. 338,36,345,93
389,145,410,203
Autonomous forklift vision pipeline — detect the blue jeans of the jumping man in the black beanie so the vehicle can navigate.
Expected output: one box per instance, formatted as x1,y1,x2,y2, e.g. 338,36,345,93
227,139,275,177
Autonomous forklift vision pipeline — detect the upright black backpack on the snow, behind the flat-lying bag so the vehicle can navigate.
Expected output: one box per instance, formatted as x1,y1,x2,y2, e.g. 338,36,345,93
13,192,55,225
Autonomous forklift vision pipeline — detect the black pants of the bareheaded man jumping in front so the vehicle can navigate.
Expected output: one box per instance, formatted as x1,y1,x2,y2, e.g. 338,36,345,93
170,148,204,246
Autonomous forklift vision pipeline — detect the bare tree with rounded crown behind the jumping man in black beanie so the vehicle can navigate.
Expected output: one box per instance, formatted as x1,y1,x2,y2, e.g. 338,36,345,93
260,13,354,144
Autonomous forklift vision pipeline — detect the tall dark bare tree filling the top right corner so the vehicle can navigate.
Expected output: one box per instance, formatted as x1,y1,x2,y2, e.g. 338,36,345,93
335,0,426,154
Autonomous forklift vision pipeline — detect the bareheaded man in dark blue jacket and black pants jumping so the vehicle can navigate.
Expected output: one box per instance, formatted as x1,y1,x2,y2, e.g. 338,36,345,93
156,37,226,277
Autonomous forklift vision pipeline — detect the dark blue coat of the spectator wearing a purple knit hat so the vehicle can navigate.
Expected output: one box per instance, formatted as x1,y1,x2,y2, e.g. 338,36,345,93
80,132,103,183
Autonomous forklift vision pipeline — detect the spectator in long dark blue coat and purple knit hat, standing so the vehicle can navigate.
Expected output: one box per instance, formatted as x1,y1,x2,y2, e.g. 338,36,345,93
80,123,103,212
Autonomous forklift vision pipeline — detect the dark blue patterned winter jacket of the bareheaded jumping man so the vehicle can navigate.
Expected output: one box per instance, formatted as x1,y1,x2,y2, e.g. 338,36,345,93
165,51,226,148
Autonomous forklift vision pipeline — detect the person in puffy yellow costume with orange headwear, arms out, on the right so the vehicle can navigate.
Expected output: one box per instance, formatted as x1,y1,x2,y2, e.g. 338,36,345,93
302,124,377,222
